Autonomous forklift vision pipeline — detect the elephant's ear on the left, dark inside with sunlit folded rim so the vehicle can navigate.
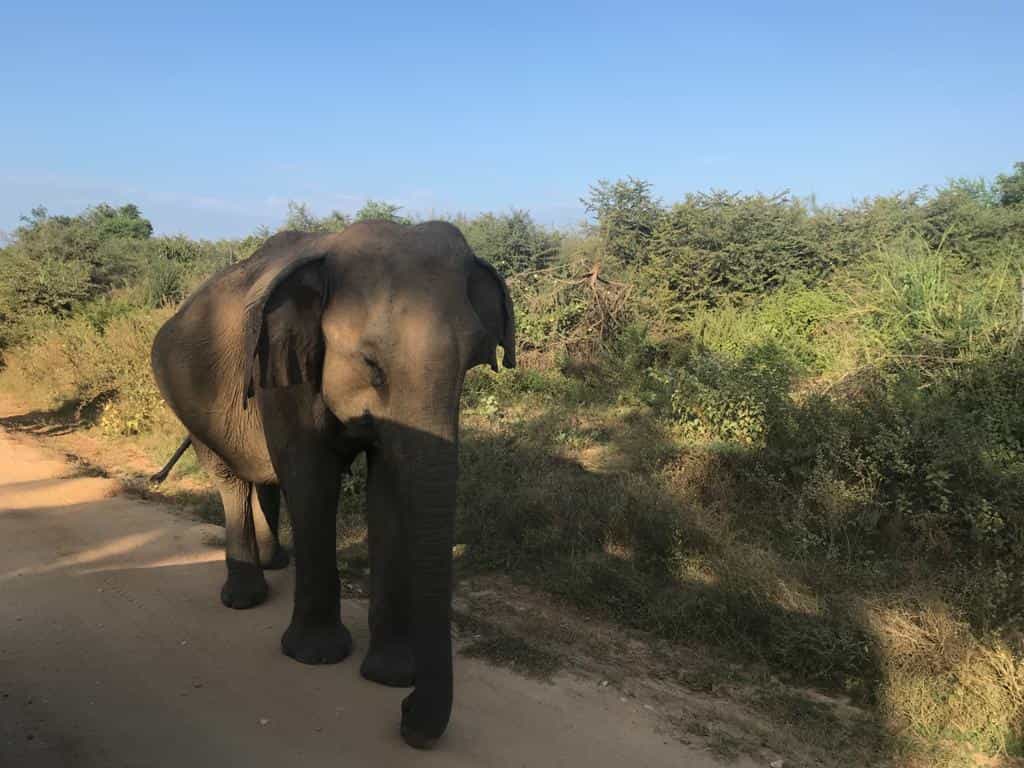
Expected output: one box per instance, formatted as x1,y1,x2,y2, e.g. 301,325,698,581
243,247,327,407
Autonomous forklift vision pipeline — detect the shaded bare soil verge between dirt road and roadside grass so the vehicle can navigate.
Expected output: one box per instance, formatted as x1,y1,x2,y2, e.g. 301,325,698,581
455,574,886,766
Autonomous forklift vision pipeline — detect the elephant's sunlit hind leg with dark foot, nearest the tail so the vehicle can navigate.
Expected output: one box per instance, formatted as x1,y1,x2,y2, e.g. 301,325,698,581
193,439,268,608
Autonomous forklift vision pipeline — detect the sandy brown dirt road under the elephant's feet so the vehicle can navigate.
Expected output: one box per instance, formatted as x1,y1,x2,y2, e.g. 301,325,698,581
0,432,741,768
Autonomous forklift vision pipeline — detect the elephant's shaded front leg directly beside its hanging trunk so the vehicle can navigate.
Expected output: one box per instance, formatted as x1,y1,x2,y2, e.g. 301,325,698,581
359,452,416,687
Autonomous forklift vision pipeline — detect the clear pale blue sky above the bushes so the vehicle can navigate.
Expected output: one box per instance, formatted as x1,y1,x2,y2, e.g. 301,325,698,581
0,0,1024,237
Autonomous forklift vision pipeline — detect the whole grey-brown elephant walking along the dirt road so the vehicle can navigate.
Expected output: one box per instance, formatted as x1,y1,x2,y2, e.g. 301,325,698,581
152,221,516,749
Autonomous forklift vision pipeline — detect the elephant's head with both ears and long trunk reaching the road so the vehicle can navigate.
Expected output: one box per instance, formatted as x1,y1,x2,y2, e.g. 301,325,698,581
240,221,515,745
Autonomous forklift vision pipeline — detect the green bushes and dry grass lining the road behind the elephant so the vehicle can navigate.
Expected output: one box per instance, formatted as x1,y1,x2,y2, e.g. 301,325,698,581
0,163,1024,765
